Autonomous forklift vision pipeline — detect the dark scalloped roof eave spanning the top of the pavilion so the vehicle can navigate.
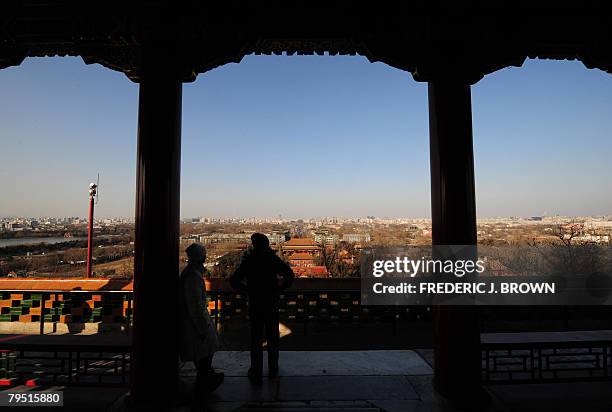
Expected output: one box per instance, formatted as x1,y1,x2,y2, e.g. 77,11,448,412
0,0,612,83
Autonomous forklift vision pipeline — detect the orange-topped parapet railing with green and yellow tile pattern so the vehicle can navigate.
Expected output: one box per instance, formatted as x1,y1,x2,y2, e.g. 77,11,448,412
0,278,429,333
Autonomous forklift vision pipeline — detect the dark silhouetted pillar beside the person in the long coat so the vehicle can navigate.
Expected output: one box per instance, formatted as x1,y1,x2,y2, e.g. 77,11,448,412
131,59,182,410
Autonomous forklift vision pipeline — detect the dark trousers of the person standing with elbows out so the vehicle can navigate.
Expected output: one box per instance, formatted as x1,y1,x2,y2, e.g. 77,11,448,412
249,307,280,375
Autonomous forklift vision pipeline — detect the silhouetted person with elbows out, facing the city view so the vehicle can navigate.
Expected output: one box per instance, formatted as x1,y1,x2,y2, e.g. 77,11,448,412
230,233,295,384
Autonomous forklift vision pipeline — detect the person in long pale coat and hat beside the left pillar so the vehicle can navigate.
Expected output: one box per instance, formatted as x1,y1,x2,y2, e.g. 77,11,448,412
179,243,223,411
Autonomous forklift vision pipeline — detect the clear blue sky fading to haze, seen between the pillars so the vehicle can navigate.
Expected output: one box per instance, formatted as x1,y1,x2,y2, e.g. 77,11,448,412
0,56,612,217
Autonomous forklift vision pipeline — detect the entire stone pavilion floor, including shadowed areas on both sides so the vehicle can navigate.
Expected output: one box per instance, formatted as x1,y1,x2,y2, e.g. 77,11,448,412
0,350,612,412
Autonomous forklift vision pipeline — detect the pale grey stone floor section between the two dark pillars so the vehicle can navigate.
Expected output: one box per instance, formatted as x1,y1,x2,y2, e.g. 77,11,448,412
182,350,432,412
